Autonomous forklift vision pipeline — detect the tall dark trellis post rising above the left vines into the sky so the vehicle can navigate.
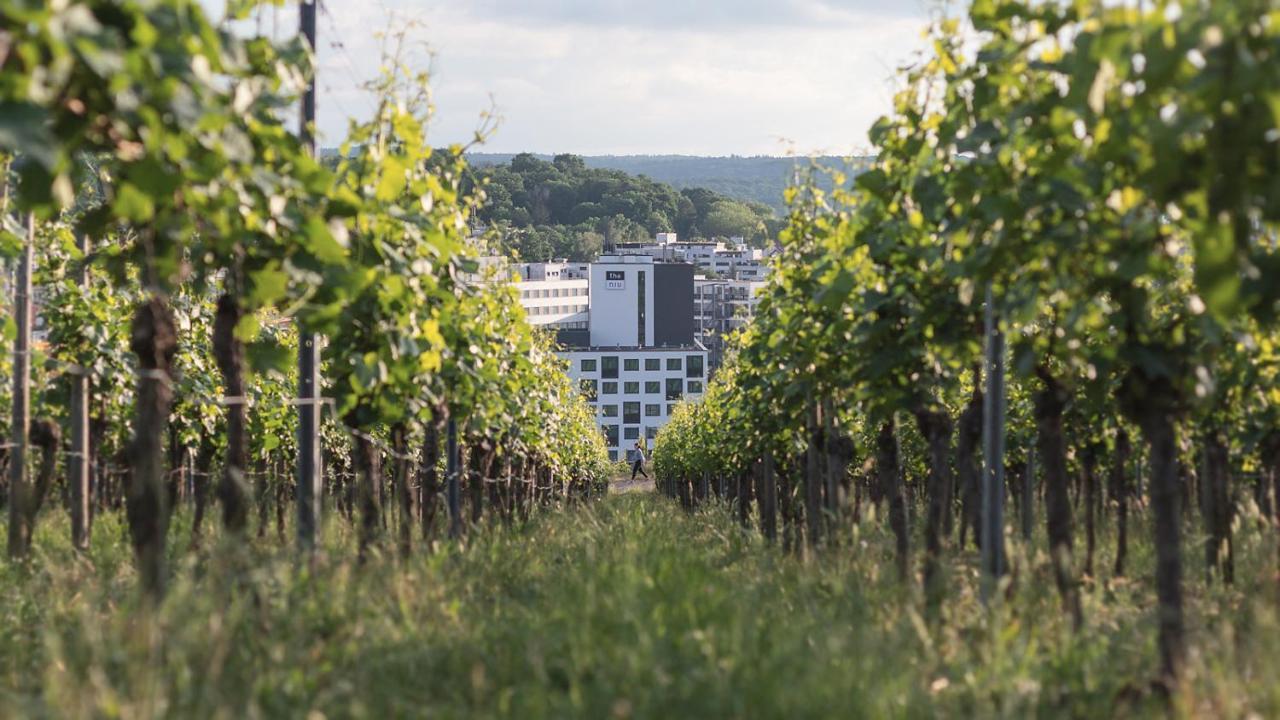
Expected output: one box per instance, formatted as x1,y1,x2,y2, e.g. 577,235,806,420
298,0,321,552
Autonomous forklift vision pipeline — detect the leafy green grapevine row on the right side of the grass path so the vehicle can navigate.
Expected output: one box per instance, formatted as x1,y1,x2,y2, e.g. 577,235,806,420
654,0,1280,715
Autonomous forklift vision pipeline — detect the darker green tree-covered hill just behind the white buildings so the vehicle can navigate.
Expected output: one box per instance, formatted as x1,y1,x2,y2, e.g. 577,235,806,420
471,154,782,261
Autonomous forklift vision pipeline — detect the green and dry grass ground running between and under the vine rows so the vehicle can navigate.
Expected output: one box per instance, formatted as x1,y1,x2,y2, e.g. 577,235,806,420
0,493,1280,717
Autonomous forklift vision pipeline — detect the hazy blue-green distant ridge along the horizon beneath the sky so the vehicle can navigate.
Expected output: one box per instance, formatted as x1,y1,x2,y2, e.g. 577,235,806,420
468,152,865,208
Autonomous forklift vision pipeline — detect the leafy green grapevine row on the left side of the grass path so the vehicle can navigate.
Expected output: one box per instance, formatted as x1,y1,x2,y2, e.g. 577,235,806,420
0,0,608,589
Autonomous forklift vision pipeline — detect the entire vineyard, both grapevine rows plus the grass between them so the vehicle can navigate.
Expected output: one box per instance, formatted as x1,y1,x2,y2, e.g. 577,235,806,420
0,0,1280,717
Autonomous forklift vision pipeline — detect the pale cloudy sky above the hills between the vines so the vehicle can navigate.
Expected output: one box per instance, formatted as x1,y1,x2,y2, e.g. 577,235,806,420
232,0,931,155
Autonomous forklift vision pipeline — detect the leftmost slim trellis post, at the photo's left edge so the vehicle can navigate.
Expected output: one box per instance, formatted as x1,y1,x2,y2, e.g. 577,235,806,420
9,213,36,557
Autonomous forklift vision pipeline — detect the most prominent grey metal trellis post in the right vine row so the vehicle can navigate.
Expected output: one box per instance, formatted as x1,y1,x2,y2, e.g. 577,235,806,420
982,283,1005,598
